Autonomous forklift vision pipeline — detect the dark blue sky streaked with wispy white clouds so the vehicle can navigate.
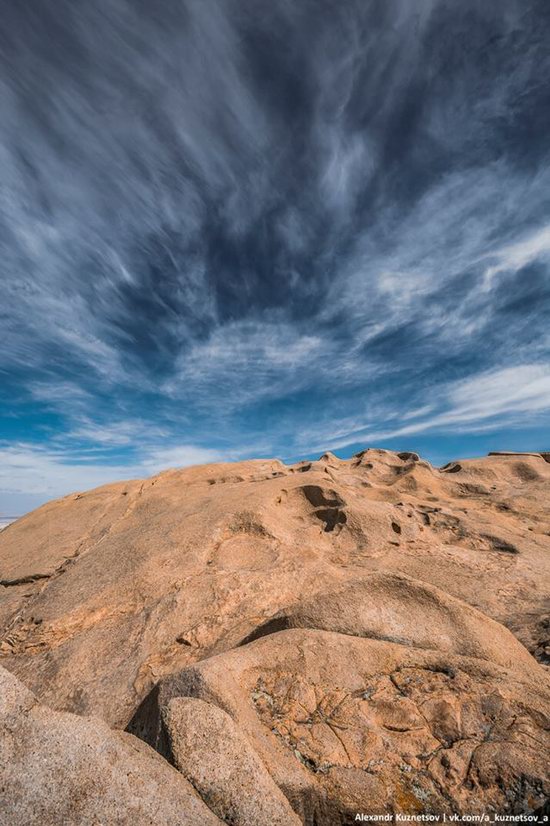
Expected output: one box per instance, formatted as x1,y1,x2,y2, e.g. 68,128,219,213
0,0,550,515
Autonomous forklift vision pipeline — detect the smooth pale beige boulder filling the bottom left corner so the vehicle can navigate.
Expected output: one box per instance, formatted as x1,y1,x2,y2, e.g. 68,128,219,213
0,668,220,826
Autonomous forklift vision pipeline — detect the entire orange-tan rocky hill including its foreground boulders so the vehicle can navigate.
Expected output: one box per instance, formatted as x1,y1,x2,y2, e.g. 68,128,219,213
0,450,550,826
